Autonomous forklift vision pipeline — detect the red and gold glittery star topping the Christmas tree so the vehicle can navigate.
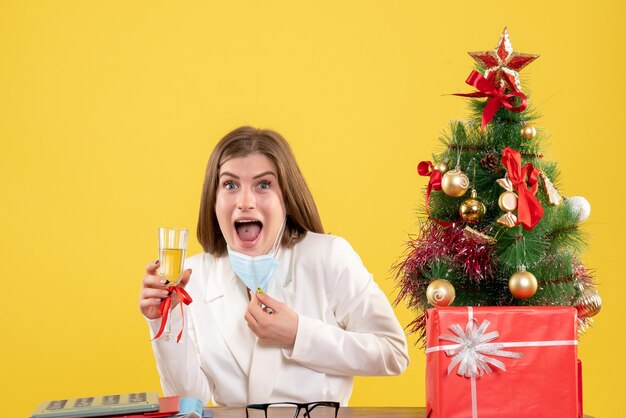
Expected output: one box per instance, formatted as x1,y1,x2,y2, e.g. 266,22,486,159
468,28,539,92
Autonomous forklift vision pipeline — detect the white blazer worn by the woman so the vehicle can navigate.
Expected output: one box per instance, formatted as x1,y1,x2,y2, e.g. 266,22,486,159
148,232,409,406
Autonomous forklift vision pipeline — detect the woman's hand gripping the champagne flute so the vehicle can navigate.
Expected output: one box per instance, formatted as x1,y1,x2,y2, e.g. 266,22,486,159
139,260,191,319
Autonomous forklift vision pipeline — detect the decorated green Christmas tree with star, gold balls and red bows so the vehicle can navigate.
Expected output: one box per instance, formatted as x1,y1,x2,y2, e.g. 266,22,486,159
394,28,601,342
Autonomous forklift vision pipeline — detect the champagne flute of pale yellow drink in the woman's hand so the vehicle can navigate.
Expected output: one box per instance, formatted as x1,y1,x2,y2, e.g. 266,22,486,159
158,227,189,341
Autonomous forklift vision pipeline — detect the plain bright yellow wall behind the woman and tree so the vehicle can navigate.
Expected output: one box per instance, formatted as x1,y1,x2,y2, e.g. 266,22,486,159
0,0,626,418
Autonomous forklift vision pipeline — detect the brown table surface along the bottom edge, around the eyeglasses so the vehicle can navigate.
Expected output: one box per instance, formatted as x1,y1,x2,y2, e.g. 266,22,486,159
210,407,592,418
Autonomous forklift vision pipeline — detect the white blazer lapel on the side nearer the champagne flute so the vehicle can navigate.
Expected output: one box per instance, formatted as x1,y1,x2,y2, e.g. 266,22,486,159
205,257,256,375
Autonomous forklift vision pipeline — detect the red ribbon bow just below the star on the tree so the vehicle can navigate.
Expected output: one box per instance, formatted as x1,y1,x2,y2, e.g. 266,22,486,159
454,70,528,131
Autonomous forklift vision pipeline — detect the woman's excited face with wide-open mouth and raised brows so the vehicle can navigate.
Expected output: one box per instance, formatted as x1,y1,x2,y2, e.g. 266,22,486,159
215,153,286,256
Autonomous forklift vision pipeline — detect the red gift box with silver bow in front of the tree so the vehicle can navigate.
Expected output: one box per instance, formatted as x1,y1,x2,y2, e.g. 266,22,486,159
426,306,582,418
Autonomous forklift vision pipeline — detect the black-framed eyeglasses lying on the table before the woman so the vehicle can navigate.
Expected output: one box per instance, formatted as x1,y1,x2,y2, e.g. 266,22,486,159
246,401,339,418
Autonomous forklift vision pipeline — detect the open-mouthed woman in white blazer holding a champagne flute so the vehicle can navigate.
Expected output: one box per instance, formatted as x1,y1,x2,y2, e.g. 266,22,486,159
139,127,409,405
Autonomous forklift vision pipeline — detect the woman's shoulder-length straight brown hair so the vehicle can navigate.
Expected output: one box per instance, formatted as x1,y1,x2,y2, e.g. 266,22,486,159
197,126,324,257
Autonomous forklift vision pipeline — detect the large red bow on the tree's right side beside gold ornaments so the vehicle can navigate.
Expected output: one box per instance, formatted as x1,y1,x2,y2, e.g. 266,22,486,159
502,147,543,231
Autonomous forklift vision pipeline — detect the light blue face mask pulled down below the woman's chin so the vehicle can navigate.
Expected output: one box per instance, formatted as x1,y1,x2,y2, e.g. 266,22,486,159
226,219,287,293
